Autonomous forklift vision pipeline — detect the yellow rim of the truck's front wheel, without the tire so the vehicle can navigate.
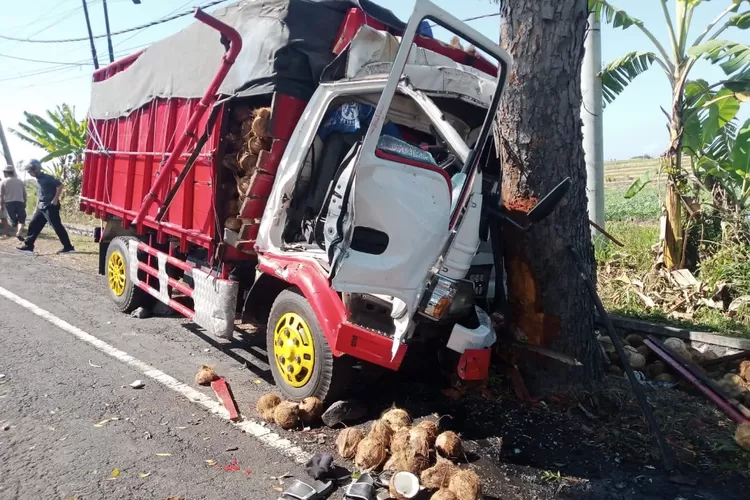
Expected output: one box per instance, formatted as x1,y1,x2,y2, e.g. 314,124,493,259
273,313,315,388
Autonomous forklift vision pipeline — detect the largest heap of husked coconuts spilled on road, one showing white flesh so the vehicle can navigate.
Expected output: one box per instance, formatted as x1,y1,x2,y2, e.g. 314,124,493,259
336,408,481,500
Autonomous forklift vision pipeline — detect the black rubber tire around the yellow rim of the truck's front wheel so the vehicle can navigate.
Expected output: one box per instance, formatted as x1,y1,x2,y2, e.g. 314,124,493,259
266,288,351,403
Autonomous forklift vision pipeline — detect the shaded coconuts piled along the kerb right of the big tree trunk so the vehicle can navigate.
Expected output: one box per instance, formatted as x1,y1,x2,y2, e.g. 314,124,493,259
599,333,750,407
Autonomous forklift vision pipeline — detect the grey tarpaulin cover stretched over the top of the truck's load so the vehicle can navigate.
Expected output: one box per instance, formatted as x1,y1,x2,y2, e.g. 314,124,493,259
89,0,404,119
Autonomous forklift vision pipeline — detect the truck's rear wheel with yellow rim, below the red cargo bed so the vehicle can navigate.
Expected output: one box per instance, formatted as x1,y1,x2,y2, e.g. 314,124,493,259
105,236,150,313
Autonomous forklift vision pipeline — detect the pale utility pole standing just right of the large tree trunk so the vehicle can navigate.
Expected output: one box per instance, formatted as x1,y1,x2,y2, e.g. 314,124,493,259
581,13,604,244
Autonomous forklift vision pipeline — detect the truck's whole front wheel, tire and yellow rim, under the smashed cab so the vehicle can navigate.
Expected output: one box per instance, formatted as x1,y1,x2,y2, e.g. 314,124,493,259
266,289,350,402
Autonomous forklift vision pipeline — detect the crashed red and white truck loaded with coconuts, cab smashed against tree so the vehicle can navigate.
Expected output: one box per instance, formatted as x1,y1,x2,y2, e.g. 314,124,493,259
80,0,568,400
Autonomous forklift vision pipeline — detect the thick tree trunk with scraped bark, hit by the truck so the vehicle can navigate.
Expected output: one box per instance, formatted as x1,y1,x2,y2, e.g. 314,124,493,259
498,0,603,392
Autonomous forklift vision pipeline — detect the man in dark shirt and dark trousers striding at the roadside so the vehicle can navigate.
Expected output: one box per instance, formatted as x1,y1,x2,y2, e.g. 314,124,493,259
18,160,75,254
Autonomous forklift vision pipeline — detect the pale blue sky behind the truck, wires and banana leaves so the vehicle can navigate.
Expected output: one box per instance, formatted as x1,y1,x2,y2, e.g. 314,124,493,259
0,0,750,162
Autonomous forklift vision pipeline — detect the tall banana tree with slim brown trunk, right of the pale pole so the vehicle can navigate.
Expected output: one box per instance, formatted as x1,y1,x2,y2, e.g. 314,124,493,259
589,0,750,269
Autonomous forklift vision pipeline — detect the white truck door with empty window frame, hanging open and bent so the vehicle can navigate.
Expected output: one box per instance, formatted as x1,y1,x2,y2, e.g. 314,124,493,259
325,0,512,316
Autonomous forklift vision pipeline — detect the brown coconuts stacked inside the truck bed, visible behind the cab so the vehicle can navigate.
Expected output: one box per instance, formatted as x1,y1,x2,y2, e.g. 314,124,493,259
223,104,271,231
